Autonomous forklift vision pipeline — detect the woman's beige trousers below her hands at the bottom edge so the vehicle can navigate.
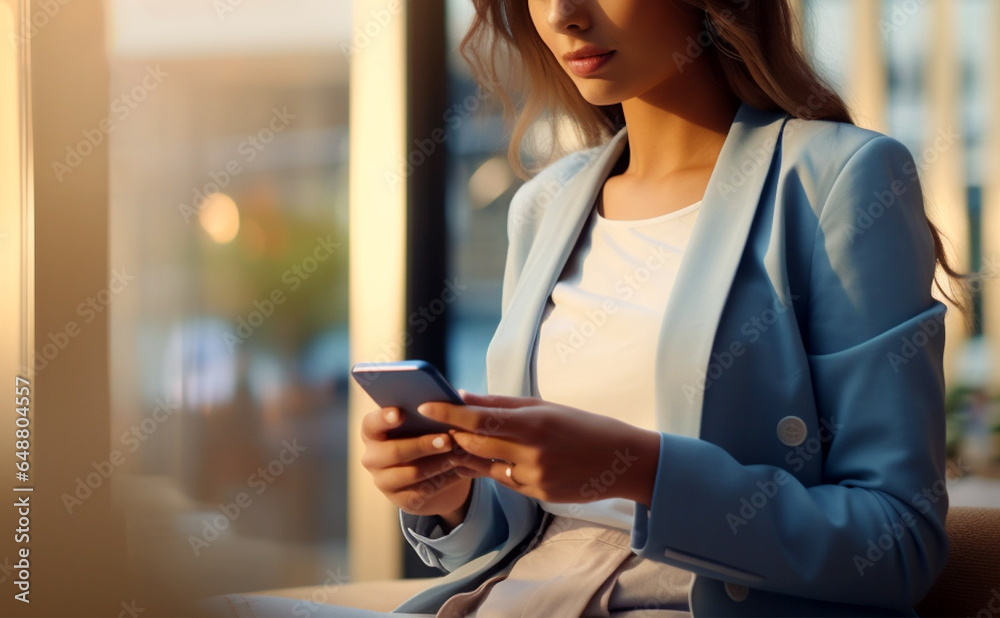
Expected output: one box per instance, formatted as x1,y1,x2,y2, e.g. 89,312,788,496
200,515,693,618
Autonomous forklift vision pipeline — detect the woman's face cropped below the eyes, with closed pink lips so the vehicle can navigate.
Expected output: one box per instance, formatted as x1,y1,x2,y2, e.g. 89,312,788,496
526,0,707,105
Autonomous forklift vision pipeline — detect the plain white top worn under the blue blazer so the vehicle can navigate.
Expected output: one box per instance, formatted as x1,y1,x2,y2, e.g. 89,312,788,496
532,197,701,531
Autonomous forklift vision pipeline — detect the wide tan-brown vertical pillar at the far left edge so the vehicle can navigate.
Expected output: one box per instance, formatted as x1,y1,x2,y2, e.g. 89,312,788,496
6,0,124,616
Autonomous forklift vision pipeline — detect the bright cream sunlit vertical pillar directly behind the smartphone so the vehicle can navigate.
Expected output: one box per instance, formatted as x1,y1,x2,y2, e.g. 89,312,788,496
347,0,410,581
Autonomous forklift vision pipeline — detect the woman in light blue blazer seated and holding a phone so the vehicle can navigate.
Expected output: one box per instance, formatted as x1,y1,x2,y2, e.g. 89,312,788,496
201,0,959,616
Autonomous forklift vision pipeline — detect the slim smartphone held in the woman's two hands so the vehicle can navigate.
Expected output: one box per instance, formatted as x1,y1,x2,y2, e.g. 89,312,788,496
351,360,465,439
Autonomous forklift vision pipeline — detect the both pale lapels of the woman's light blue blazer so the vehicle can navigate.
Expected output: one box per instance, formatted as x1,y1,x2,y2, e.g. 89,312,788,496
487,104,787,437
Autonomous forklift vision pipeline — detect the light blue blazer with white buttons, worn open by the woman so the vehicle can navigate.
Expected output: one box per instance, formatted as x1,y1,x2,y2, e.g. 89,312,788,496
396,105,948,616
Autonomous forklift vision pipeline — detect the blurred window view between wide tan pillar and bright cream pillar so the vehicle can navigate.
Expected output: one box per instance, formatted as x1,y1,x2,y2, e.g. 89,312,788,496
107,0,351,594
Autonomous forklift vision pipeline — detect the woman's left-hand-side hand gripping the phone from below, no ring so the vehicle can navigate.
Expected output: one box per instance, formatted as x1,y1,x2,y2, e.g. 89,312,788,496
361,407,474,527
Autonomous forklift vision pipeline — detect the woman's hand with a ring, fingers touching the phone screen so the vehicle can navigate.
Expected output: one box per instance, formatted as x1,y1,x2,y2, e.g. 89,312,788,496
417,392,660,505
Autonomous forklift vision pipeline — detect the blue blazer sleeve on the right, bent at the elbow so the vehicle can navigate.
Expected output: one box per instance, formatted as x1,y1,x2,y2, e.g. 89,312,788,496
632,136,948,608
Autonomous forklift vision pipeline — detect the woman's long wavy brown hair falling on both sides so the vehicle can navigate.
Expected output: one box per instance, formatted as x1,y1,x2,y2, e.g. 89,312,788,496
459,0,975,323
